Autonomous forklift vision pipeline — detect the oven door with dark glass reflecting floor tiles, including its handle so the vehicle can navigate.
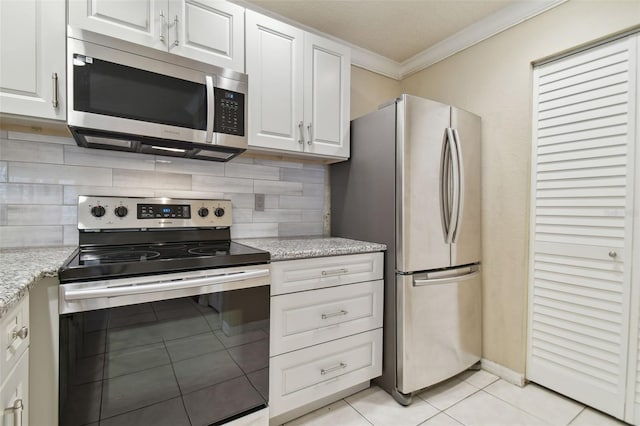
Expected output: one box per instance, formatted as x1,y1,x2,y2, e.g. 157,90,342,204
59,265,269,426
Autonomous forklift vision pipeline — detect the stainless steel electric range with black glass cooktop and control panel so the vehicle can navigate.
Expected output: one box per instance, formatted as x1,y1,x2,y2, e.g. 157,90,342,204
59,196,270,426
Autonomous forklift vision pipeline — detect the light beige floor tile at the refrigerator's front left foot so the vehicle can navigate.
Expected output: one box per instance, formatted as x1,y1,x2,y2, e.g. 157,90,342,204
346,386,438,426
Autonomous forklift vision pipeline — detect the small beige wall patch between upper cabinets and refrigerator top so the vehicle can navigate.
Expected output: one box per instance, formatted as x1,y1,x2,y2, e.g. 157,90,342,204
351,66,402,120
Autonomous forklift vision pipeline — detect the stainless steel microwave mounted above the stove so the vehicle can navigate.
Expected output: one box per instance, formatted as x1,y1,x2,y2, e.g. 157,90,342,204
67,37,247,161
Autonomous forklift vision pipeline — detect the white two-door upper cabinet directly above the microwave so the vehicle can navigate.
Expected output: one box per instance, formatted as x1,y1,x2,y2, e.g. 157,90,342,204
69,0,244,72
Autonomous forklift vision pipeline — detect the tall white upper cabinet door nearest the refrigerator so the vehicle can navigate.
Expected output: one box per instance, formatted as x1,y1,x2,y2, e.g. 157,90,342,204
304,34,351,158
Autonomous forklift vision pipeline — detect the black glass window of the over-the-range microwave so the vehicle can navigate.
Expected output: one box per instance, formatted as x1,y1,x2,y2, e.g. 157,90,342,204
73,54,207,130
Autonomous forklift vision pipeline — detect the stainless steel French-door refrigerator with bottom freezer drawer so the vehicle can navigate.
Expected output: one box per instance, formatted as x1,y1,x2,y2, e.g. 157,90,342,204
331,95,482,405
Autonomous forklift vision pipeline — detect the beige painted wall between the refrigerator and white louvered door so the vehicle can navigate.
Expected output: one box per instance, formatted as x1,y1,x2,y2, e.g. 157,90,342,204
400,0,640,373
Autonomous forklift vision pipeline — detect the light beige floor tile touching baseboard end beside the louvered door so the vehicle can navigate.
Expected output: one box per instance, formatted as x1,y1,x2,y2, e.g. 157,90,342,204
484,380,584,426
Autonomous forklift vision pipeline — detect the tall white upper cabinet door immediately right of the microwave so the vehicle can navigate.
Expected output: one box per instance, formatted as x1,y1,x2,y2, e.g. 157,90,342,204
246,10,304,152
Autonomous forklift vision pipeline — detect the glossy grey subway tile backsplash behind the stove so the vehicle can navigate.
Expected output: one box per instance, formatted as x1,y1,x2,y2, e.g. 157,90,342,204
0,130,327,248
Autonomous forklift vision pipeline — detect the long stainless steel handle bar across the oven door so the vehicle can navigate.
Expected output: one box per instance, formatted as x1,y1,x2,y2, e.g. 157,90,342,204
61,269,270,301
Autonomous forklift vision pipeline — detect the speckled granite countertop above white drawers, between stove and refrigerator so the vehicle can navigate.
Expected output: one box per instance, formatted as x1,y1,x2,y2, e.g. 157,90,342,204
234,237,387,261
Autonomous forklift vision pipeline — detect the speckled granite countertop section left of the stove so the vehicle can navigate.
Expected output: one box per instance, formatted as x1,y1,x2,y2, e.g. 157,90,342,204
0,247,75,318
